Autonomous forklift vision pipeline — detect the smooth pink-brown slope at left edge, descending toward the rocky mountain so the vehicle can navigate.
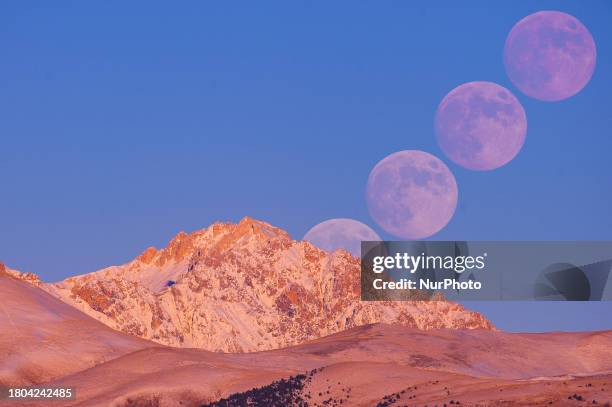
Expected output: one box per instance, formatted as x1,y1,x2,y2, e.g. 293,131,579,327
0,263,153,386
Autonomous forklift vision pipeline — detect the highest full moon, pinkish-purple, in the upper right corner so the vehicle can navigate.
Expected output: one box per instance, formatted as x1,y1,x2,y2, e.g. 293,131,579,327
504,11,597,101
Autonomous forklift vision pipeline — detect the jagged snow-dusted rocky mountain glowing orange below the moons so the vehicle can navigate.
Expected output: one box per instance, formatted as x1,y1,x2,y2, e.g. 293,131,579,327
42,218,493,352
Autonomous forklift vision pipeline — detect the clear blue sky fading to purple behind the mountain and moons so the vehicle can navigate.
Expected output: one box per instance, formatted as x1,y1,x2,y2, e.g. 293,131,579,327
0,1,612,330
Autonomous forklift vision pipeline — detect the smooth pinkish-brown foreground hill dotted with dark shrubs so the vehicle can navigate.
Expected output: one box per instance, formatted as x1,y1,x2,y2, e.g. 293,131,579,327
17,324,612,407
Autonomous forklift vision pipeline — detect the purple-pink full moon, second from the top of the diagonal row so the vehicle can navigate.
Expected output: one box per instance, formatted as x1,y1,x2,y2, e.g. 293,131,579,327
435,82,527,171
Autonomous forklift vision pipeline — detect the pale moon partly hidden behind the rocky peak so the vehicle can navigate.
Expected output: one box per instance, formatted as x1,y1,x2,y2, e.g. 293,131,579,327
303,218,380,257
